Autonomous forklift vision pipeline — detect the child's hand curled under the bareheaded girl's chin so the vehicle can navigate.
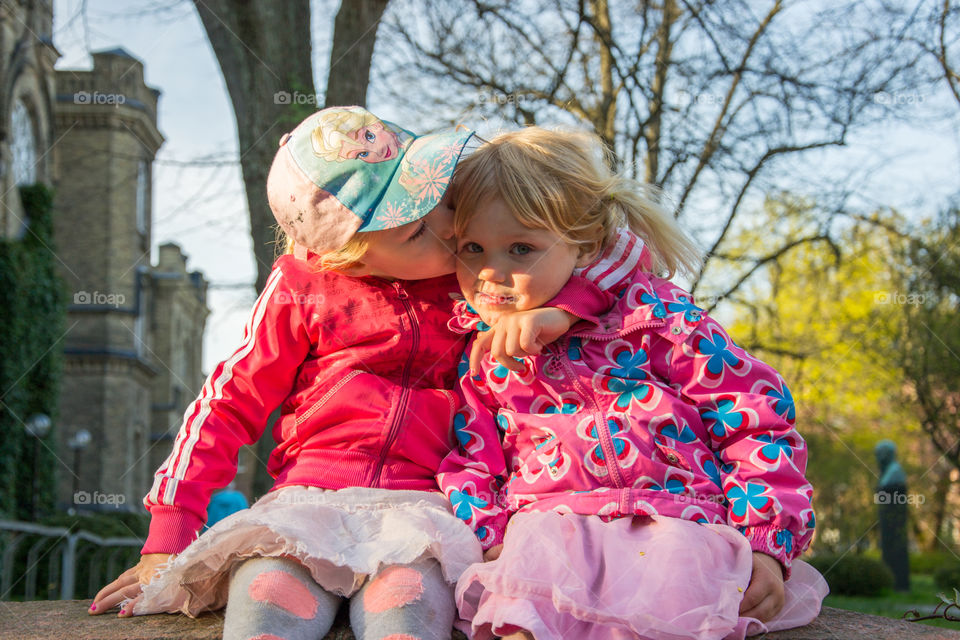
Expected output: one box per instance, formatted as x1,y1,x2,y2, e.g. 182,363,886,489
470,307,580,372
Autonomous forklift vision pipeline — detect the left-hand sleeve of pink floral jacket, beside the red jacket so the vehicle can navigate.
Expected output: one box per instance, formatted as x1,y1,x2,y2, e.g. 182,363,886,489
437,356,509,550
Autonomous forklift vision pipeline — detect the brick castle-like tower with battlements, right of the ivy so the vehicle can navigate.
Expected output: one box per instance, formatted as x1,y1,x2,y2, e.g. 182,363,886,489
52,49,208,509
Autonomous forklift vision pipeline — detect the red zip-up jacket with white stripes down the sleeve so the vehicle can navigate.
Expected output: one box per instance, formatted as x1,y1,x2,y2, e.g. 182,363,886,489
142,255,464,553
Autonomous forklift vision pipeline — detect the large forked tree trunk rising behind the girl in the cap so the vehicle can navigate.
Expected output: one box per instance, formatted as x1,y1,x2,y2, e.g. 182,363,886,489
194,0,388,291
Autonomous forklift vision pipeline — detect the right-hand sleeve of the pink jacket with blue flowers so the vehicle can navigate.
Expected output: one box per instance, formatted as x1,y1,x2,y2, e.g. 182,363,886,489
669,315,814,578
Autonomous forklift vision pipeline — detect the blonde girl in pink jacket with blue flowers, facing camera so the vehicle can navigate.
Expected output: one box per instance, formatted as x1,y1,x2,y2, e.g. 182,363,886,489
438,127,826,640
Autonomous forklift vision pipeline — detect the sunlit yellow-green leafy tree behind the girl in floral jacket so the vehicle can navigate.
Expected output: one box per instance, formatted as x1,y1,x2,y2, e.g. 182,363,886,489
712,194,960,553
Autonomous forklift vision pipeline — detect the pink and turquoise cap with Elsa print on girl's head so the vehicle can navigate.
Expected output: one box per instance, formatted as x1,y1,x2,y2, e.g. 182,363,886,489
267,107,473,257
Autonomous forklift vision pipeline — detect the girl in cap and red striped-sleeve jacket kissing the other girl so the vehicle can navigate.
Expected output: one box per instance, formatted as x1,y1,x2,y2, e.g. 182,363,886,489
90,107,584,640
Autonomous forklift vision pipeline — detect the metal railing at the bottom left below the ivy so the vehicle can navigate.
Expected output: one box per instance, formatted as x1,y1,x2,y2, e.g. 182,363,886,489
0,520,143,601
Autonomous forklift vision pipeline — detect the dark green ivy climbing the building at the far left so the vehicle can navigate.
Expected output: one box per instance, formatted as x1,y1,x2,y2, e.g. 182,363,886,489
0,184,66,520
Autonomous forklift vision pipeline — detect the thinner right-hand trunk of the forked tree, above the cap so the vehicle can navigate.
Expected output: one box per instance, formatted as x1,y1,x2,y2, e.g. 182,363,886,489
324,0,389,107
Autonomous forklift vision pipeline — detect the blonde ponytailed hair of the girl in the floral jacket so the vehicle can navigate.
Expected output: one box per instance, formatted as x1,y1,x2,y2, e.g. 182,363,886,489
453,127,702,277
